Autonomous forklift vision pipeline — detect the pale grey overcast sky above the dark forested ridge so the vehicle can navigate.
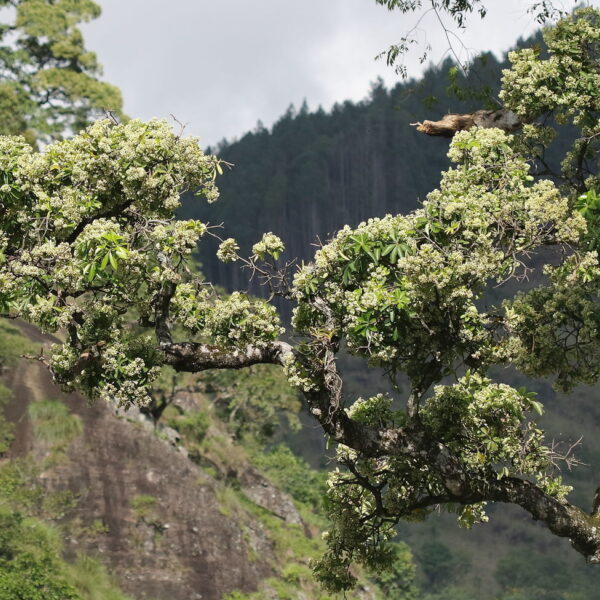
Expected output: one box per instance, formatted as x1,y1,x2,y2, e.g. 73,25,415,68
84,0,600,145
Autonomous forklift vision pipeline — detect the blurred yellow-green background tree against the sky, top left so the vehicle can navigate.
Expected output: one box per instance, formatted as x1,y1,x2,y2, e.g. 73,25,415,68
0,0,122,142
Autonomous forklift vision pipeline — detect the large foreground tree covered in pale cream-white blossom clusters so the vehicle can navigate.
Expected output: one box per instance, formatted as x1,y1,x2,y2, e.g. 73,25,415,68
0,3,600,590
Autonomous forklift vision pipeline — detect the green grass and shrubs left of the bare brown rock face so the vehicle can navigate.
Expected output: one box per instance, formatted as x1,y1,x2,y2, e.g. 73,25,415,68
0,344,129,600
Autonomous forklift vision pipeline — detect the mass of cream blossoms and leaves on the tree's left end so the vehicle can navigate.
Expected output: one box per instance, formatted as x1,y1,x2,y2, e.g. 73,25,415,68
0,120,221,403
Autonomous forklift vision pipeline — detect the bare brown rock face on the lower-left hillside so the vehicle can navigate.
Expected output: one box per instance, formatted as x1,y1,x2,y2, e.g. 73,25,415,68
5,328,300,600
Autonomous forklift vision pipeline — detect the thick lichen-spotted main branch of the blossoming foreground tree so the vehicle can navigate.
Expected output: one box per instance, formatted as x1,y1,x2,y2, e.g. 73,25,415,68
161,332,600,563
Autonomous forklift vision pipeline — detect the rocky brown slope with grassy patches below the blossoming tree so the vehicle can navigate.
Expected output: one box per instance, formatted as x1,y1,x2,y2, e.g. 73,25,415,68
0,325,376,600
